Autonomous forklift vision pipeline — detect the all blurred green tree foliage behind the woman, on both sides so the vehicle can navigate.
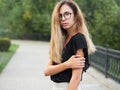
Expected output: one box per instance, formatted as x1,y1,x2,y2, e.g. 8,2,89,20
0,0,120,50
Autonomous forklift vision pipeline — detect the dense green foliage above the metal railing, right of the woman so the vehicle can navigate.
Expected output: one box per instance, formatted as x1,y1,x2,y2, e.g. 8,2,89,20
76,0,120,50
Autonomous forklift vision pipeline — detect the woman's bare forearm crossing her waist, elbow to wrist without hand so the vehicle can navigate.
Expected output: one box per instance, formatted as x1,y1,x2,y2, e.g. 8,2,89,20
44,62,69,76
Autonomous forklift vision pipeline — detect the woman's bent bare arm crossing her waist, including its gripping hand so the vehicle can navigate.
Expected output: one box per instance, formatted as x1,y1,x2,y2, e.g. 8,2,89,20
44,55,85,76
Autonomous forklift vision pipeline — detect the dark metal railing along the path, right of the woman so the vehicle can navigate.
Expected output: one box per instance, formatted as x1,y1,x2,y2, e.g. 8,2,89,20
90,46,120,83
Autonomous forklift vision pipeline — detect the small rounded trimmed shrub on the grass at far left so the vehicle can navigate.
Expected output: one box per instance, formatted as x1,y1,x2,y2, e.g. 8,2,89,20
0,38,11,51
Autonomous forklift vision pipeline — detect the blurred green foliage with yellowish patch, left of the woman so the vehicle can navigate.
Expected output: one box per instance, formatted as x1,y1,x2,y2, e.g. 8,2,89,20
0,0,56,35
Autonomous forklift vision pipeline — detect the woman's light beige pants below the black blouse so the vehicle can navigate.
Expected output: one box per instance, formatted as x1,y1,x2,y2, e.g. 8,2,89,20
52,83,81,90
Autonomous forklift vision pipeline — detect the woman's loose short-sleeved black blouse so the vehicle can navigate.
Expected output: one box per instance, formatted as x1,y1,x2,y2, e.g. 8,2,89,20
51,33,89,83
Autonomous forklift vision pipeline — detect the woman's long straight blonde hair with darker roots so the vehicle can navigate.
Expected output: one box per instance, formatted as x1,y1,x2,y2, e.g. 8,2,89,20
49,0,96,63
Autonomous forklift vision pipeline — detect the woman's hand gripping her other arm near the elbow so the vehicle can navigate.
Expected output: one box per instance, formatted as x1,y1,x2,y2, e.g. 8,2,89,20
65,55,85,68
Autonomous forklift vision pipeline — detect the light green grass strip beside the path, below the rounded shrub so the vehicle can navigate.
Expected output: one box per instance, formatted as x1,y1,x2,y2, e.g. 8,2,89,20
0,44,18,73
